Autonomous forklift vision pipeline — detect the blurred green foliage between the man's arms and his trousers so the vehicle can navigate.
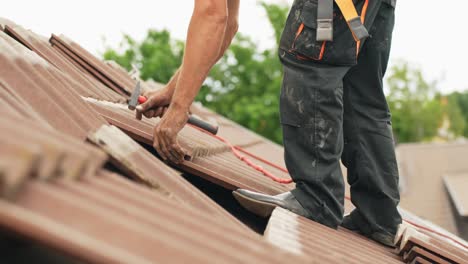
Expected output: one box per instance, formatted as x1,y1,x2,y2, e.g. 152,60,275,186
197,3,288,143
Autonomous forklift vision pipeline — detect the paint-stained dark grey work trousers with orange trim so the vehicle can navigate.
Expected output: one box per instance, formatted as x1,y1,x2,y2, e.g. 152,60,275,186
279,0,401,234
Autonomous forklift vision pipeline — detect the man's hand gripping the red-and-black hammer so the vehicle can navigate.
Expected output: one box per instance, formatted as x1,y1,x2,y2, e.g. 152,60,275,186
136,87,174,120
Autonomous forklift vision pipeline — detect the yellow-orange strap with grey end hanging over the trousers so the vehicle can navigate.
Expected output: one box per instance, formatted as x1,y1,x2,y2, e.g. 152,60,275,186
335,0,369,42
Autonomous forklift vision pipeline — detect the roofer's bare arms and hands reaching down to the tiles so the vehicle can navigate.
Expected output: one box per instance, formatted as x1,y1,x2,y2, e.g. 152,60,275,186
137,0,238,163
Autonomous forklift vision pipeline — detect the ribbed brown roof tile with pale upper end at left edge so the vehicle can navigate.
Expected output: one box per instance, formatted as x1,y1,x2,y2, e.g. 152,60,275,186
0,32,105,136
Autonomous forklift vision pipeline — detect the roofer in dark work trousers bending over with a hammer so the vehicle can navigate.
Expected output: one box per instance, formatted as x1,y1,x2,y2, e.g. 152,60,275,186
139,0,401,246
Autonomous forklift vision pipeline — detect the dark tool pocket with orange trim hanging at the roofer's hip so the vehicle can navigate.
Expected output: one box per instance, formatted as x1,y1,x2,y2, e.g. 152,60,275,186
280,0,363,66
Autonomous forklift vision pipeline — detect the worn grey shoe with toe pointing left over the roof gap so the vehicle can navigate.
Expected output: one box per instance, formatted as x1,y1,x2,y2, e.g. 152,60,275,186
232,189,309,218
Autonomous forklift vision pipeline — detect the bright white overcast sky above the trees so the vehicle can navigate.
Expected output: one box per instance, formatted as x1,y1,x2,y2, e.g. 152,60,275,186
0,0,468,93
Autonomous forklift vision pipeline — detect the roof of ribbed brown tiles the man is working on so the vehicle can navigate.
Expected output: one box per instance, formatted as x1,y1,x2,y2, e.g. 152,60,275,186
0,19,466,263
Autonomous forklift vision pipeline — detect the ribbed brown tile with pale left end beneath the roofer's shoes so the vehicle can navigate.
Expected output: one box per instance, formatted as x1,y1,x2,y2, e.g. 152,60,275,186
265,208,401,263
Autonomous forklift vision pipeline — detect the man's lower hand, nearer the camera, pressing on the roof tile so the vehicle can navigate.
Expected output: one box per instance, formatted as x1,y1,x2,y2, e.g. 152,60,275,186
153,104,189,164
